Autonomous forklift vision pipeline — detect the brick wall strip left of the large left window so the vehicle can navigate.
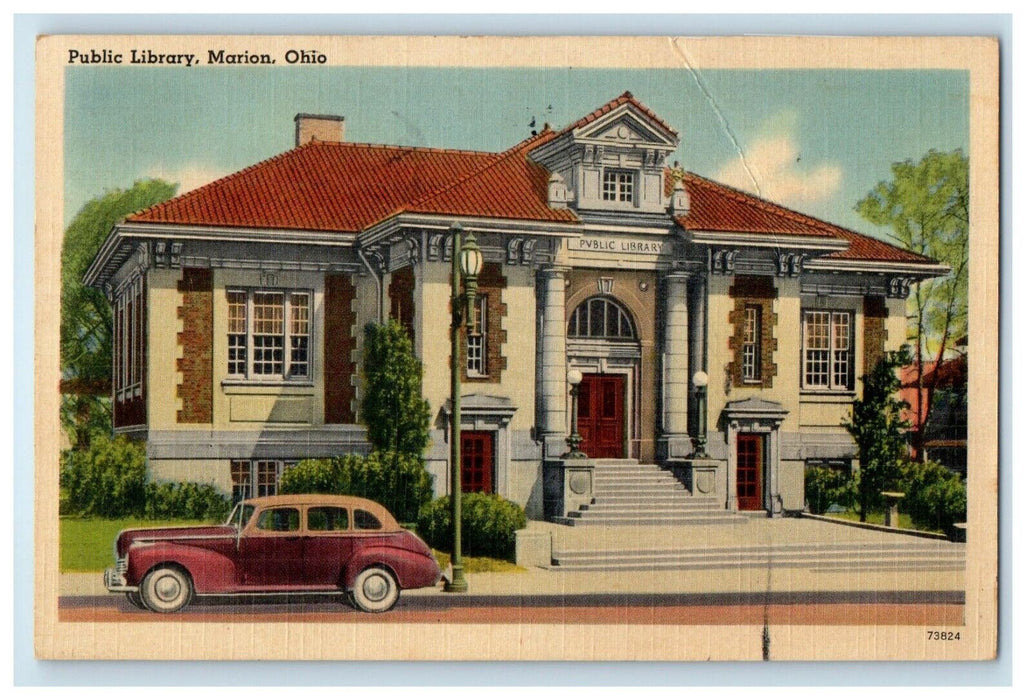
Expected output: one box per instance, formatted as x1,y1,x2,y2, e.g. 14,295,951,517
176,267,213,423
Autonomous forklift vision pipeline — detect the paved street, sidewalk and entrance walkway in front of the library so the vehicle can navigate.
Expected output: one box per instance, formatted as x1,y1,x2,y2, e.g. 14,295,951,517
59,518,965,626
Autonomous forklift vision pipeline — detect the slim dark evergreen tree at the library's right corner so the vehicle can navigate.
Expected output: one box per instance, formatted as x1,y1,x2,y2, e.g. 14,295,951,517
843,347,910,522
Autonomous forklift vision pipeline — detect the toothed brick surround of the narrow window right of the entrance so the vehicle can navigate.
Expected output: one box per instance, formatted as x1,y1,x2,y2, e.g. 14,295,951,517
725,275,778,389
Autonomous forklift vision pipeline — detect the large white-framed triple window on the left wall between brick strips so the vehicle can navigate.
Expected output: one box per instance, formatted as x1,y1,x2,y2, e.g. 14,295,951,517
226,289,312,380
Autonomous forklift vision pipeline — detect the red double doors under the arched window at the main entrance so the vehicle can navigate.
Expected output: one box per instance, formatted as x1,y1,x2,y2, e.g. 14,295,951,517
577,375,624,459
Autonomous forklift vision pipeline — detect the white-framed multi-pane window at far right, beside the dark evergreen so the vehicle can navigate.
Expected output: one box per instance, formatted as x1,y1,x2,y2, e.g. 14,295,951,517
803,311,853,390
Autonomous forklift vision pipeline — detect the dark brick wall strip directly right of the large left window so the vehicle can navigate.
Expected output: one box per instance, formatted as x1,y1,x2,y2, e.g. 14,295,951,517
323,275,356,423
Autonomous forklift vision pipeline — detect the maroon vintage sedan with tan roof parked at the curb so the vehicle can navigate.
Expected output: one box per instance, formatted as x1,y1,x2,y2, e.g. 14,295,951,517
104,495,443,612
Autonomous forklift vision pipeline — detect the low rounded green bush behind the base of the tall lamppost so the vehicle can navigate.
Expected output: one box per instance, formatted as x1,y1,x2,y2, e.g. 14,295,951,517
417,494,527,561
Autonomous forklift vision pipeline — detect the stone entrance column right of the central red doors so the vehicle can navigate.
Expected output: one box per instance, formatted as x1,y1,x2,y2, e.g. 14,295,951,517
659,271,692,459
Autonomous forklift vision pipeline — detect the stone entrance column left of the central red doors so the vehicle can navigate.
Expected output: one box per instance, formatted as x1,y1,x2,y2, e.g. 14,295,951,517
536,266,567,457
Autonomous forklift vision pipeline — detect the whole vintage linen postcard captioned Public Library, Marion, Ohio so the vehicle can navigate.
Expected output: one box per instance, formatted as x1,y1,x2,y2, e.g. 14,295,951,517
35,35,999,661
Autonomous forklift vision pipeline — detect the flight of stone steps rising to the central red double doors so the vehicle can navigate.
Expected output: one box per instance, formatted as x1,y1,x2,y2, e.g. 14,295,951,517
554,459,746,527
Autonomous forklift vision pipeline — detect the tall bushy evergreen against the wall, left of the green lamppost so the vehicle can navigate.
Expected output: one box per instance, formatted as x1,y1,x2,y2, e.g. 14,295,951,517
359,319,431,457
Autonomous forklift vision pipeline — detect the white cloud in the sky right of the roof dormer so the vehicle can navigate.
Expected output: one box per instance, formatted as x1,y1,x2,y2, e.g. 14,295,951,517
716,133,843,206
